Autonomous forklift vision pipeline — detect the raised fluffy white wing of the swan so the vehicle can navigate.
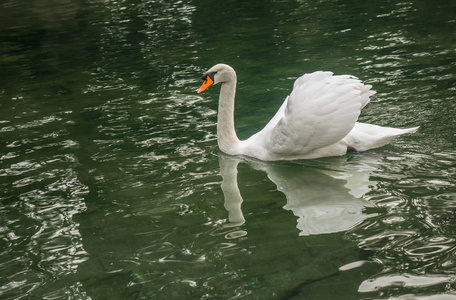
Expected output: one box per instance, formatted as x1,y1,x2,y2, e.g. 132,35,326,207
260,71,375,156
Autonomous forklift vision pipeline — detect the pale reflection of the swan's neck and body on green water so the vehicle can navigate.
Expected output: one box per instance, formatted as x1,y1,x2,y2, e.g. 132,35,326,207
219,155,378,235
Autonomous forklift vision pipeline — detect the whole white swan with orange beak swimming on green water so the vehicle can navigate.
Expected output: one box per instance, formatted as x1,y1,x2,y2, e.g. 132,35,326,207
198,64,418,161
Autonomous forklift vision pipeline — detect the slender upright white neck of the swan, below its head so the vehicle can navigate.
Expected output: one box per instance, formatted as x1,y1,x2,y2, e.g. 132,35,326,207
217,71,239,154
